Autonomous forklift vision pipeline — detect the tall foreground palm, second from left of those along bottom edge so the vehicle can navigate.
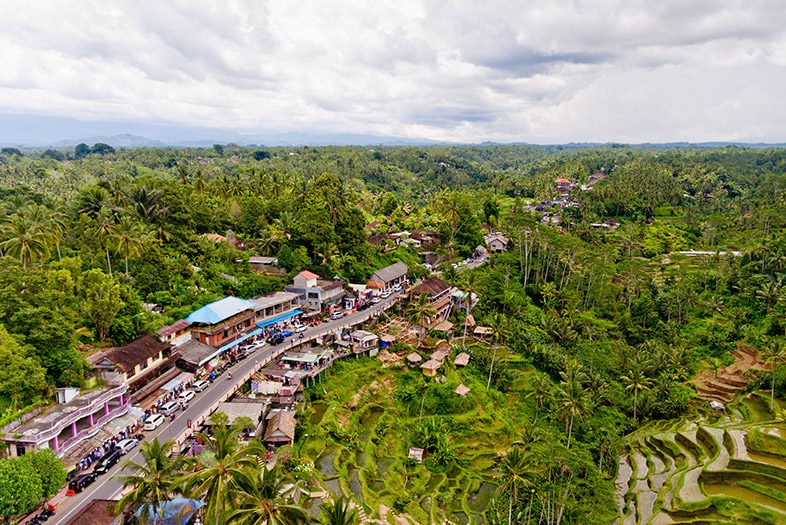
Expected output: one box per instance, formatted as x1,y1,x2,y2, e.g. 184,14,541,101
180,425,264,525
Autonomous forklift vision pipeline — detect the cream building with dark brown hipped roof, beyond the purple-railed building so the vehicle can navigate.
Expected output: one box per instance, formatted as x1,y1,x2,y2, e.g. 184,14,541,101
88,335,180,402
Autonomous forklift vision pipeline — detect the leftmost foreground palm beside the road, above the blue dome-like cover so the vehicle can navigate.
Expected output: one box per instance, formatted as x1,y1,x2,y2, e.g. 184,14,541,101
115,437,182,525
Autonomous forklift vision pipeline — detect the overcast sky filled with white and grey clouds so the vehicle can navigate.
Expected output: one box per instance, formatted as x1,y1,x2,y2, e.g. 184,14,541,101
0,0,786,143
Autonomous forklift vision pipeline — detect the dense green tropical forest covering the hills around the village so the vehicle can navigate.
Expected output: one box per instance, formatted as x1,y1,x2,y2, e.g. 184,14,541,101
0,144,786,524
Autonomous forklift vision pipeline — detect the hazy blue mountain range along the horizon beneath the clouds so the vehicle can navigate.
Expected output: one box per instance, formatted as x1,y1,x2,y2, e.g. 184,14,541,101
0,113,786,149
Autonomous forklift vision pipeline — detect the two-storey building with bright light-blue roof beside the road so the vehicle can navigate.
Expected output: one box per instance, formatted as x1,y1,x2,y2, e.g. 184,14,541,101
186,296,256,351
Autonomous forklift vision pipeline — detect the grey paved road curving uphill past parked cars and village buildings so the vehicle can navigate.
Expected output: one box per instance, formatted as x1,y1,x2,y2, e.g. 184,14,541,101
47,294,399,525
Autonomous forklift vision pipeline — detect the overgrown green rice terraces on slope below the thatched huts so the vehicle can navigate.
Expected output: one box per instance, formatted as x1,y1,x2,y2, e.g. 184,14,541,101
292,358,520,524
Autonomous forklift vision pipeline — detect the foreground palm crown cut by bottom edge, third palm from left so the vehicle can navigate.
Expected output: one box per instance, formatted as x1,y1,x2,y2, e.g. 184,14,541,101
225,467,309,525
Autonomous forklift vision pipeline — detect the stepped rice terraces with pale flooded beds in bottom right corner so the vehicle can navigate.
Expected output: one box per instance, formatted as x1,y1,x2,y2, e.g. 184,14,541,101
616,394,786,525
